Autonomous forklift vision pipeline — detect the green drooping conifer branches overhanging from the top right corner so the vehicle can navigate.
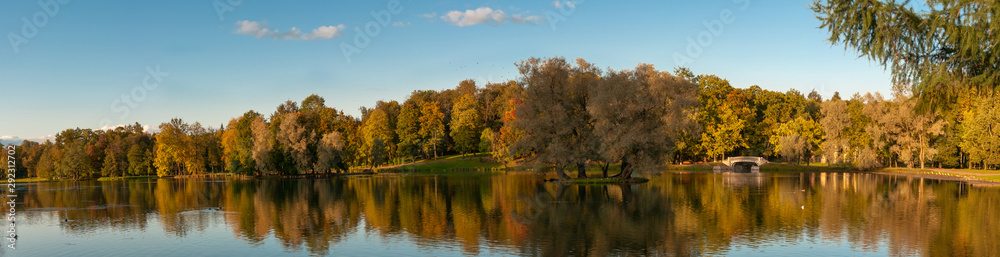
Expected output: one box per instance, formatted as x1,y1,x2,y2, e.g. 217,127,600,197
811,0,1000,109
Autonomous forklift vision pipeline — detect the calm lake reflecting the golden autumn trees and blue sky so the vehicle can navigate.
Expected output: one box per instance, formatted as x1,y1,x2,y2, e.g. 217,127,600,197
0,172,1000,256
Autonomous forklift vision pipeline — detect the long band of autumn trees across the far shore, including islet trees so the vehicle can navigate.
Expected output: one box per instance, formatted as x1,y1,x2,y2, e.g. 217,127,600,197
7,57,1000,179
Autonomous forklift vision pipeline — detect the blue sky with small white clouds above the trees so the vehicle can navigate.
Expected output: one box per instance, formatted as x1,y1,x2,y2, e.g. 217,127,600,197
0,0,891,140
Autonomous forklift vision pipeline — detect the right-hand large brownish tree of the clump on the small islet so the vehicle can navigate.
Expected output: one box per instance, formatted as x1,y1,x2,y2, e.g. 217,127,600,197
587,64,699,178
